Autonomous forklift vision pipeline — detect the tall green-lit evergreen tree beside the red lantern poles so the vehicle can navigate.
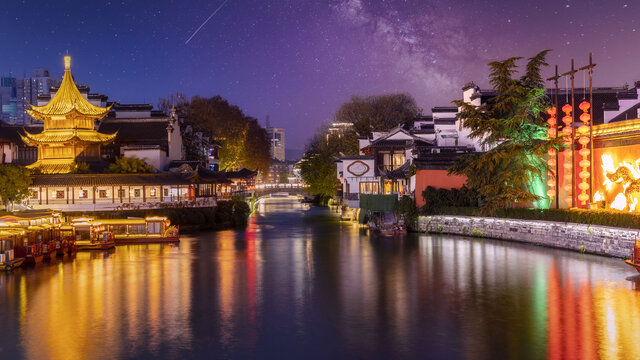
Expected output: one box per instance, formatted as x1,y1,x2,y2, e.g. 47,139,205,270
449,50,561,214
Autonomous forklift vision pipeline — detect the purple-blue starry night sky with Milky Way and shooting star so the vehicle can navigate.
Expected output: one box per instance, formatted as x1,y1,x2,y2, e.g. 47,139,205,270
0,0,640,149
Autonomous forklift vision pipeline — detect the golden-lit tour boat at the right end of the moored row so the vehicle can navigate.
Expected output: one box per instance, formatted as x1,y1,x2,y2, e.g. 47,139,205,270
72,216,180,244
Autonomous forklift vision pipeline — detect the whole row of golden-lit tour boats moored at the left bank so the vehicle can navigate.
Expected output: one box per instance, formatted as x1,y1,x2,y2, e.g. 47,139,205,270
0,210,180,270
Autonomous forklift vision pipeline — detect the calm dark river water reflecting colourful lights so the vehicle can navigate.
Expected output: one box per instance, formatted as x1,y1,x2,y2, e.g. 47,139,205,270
0,199,640,359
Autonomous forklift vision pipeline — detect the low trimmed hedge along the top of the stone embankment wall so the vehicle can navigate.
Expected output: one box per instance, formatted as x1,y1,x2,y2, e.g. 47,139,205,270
430,206,640,229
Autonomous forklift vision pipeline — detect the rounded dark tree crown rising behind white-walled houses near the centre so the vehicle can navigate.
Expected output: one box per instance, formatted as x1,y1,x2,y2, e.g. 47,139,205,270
335,94,421,136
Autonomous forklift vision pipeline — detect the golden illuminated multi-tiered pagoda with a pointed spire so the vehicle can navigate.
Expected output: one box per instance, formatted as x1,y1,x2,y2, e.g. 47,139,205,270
21,56,117,174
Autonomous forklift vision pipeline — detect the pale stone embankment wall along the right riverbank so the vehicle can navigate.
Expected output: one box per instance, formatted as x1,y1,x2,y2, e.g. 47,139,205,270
418,215,640,258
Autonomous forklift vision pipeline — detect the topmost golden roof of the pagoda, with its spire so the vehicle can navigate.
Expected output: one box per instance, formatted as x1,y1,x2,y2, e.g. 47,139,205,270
27,56,111,121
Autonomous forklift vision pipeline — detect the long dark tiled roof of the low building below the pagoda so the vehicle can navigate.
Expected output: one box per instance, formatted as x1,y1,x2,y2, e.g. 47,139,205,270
31,173,191,187
